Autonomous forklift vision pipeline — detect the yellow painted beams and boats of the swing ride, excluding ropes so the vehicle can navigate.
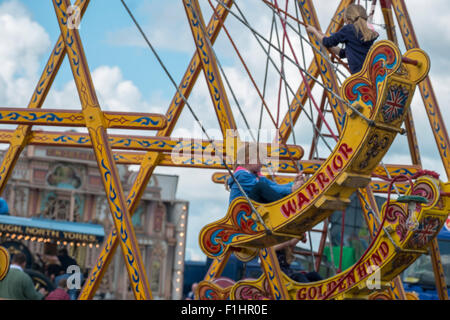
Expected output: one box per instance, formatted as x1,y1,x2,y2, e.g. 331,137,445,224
0,0,450,300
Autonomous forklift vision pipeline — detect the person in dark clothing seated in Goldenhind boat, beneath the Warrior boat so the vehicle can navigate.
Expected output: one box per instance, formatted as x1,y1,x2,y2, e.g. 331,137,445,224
274,237,322,283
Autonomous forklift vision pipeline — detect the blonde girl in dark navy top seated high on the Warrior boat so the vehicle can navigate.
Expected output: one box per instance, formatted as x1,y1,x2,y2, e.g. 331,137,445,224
306,4,379,74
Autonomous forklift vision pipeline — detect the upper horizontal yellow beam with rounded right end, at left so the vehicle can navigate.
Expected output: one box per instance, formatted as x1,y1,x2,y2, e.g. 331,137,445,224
0,108,167,130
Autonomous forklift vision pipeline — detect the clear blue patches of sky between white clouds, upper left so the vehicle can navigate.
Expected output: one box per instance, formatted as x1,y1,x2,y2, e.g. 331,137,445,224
21,0,189,99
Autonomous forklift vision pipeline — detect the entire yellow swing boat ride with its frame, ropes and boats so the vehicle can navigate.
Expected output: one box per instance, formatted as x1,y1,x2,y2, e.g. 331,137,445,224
0,0,450,300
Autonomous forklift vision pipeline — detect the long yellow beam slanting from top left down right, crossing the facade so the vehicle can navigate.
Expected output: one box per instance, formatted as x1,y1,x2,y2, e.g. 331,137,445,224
53,0,152,300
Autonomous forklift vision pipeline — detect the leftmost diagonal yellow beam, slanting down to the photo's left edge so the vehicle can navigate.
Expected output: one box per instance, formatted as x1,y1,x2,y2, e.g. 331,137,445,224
0,0,90,194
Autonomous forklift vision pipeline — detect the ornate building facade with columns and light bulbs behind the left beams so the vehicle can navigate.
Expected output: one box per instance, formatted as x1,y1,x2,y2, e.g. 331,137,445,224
0,146,189,299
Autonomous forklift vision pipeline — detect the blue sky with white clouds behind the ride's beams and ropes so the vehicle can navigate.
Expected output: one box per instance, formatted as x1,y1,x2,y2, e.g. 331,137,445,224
0,0,450,260
